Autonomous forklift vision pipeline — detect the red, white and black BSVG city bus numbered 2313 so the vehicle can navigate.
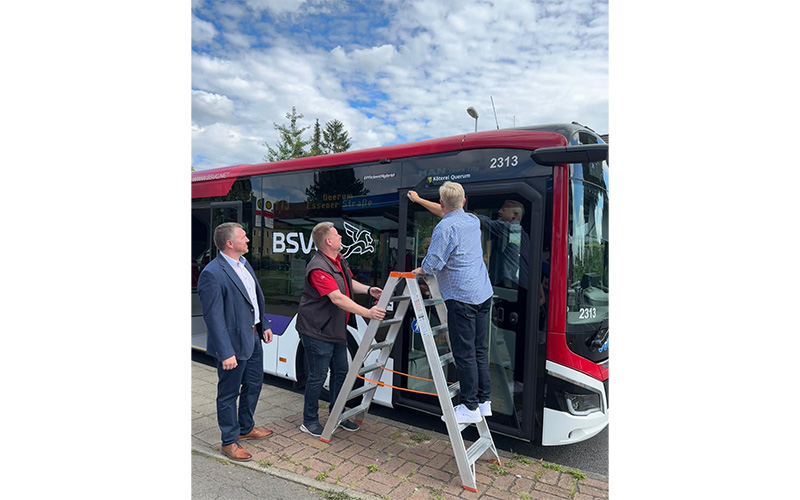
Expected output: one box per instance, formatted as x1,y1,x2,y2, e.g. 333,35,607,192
192,123,609,445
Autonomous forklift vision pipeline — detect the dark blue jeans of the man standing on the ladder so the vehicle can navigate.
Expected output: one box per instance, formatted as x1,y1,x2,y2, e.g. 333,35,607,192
445,298,492,410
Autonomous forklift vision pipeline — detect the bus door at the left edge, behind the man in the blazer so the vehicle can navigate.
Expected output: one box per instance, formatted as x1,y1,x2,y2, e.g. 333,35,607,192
192,201,242,351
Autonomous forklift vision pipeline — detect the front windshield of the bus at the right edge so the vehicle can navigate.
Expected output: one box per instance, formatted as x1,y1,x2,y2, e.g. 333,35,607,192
567,162,608,331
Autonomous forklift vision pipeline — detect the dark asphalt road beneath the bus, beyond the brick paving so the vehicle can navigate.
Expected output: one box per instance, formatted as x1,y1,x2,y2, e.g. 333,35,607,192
192,350,608,476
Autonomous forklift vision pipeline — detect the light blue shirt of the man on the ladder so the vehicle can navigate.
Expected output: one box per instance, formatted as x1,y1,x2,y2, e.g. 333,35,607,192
421,208,493,305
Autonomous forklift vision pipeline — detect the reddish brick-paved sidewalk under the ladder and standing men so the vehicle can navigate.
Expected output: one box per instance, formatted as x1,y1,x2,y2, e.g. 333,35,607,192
192,361,608,500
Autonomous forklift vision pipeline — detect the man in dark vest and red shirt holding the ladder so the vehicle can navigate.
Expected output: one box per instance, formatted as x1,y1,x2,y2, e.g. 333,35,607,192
296,222,386,437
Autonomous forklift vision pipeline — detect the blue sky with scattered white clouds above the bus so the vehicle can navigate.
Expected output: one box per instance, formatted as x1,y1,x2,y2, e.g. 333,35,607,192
191,0,609,170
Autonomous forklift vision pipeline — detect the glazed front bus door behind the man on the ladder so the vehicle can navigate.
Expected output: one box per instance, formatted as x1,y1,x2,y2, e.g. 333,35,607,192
395,182,546,439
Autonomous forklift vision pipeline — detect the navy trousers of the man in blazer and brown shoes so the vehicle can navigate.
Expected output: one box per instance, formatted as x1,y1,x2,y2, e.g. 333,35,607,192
217,332,264,446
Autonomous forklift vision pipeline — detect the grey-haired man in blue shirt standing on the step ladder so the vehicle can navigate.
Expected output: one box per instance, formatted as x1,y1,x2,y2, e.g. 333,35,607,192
409,181,493,424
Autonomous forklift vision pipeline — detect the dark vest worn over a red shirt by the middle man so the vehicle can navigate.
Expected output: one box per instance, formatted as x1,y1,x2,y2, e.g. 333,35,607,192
296,252,354,344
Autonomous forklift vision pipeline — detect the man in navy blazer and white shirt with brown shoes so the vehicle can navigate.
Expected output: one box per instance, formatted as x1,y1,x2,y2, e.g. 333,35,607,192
197,222,272,461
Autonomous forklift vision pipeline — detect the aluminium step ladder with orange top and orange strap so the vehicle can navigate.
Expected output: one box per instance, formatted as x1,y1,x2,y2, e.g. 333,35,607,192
320,271,500,492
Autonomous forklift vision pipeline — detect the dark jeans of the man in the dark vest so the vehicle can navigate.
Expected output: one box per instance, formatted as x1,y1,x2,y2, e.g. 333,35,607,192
300,334,349,426
